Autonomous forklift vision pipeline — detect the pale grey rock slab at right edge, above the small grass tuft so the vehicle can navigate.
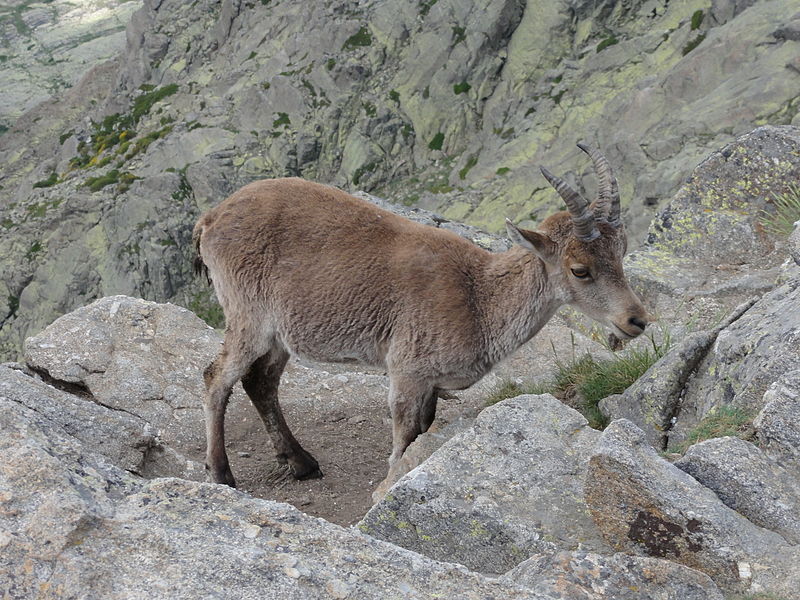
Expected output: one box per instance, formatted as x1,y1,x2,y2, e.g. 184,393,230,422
669,278,800,445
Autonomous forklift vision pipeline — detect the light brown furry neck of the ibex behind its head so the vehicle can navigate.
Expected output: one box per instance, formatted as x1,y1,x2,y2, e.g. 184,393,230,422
484,246,564,364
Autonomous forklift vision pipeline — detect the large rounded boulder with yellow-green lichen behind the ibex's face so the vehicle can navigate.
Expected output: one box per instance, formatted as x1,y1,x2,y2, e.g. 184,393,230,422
626,126,800,305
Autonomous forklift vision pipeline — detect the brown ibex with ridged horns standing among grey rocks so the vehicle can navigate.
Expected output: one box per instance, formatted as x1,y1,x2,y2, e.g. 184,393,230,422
194,144,648,486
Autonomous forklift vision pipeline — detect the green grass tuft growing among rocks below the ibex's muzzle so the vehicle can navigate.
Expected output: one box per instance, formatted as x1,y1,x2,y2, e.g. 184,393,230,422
487,330,671,429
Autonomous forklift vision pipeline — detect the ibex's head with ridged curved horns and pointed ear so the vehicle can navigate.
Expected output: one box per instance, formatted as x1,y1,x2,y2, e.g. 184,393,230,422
506,143,650,339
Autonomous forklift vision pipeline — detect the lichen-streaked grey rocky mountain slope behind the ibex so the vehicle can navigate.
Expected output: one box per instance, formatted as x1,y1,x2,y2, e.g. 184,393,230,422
0,0,800,357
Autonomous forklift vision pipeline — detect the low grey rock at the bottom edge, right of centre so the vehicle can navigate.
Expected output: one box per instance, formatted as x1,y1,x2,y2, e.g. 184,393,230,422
503,550,722,600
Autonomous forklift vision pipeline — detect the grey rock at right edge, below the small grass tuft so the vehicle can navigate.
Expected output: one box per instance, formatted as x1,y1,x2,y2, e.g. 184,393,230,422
675,437,800,545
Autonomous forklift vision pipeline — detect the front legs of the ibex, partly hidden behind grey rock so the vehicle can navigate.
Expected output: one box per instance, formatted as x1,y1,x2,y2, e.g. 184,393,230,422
389,375,436,467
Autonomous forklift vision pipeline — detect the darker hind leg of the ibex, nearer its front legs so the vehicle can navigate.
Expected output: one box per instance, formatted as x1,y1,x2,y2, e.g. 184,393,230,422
242,344,322,479
